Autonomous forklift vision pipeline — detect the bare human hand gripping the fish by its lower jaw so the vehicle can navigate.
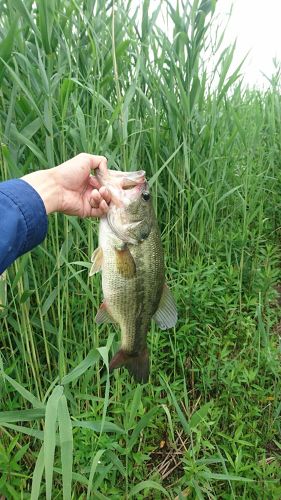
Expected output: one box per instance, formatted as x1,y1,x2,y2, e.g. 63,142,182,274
22,153,110,217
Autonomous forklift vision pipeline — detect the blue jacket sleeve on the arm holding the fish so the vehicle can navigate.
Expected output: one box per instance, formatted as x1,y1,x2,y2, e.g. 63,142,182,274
0,179,48,274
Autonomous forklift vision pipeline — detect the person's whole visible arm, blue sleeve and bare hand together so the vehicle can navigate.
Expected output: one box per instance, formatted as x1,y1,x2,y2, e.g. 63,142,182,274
0,153,110,273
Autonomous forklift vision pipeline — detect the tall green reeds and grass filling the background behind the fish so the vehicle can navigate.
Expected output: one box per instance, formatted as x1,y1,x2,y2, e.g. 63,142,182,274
0,0,281,499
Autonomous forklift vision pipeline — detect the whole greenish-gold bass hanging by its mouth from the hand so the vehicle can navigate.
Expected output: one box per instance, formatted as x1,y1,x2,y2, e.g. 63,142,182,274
90,169,177,383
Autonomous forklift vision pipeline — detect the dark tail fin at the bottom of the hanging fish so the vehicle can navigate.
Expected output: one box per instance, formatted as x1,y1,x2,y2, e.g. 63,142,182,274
109,347,149,383
